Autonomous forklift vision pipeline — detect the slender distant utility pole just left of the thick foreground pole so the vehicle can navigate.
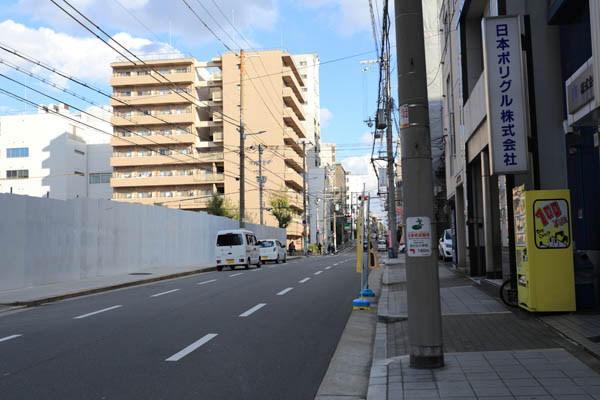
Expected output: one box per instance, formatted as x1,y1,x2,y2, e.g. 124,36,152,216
383,54,398,258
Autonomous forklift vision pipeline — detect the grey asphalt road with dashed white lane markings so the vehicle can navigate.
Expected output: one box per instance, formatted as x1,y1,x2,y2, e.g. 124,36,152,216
0,253,360,400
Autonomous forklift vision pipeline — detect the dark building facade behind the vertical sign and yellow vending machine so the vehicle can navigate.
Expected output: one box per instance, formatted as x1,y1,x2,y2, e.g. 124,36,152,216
439,0,600,278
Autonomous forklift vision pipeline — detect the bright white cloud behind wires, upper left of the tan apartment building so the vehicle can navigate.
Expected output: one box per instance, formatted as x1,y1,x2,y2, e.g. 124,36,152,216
0,20,177,85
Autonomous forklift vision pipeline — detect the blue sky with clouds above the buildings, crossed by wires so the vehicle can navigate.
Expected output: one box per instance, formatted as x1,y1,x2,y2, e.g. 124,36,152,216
0,0,392,216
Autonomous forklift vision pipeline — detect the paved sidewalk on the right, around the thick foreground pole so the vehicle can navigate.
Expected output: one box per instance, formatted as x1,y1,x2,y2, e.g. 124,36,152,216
367,258,600,400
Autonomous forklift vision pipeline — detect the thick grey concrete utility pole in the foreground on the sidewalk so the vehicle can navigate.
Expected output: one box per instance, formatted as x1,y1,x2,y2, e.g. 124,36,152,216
396,0,444,368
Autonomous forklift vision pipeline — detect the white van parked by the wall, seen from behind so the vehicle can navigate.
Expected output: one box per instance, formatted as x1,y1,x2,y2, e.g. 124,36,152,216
215,229,262,271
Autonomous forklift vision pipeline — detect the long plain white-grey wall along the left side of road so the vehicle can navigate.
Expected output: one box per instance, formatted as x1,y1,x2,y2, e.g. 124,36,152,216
0,194,286,290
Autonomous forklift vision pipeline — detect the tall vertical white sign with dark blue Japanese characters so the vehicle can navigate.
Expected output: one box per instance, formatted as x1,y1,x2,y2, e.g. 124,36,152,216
482,16,528,174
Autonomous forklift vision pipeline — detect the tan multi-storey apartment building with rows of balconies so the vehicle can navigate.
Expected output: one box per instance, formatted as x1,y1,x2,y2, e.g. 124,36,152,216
111,50,306,244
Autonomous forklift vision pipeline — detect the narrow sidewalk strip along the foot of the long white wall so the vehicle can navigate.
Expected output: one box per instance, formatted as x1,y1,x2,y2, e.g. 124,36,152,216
0,256,304,312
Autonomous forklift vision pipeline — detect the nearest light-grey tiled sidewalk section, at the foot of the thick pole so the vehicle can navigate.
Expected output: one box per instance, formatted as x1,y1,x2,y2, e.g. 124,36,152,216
388,349,600,400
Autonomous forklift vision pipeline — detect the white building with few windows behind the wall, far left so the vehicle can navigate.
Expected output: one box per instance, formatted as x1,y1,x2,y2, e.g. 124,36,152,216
0,104,112,200
